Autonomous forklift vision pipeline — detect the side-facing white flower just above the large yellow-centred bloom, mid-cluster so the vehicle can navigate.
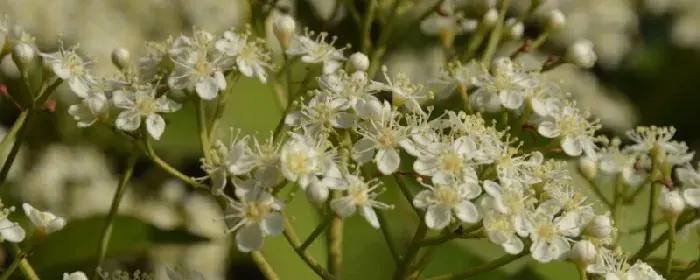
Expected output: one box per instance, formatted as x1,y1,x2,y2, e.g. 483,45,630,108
285,93,355,135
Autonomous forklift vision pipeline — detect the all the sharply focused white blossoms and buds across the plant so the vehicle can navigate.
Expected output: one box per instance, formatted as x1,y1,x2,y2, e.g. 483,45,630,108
1,1,700,280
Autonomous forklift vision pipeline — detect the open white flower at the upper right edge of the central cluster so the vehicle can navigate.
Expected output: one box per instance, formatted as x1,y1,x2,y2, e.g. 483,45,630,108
537,101,600,156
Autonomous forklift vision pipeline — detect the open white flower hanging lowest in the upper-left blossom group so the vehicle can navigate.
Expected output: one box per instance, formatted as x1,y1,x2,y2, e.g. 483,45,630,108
112,87,180,140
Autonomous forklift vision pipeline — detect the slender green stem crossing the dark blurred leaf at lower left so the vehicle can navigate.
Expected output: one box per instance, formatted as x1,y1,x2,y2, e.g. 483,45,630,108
92,153,139,279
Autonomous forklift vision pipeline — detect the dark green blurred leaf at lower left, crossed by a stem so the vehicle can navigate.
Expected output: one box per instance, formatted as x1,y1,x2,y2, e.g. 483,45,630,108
29,216,208,271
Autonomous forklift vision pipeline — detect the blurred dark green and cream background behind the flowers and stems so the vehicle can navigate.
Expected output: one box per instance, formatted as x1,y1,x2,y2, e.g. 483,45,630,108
0,0,700,280
